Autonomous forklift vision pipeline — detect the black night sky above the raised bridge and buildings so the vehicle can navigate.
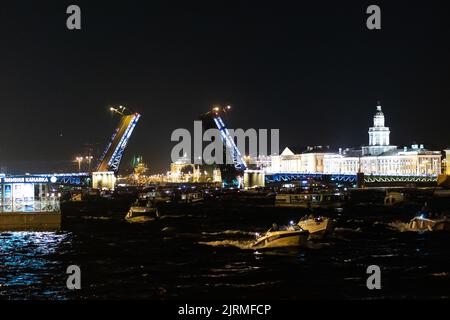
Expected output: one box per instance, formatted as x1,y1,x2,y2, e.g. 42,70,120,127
0,0,450,173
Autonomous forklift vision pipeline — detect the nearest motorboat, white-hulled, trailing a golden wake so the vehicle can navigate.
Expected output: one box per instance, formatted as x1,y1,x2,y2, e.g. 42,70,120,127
251,224,309,249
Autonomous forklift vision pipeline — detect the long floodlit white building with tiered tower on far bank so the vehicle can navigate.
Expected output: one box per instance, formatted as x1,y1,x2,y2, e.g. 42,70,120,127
263,105,442,176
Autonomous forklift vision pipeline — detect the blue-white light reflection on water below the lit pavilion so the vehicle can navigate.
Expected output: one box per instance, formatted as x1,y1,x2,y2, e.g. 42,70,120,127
0,232,70,299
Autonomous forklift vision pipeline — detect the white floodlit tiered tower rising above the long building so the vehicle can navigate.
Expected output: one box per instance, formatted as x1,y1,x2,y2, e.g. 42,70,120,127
362,103,397,155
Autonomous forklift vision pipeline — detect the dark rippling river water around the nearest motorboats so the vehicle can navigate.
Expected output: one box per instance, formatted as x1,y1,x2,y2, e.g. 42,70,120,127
0,208,450,300
